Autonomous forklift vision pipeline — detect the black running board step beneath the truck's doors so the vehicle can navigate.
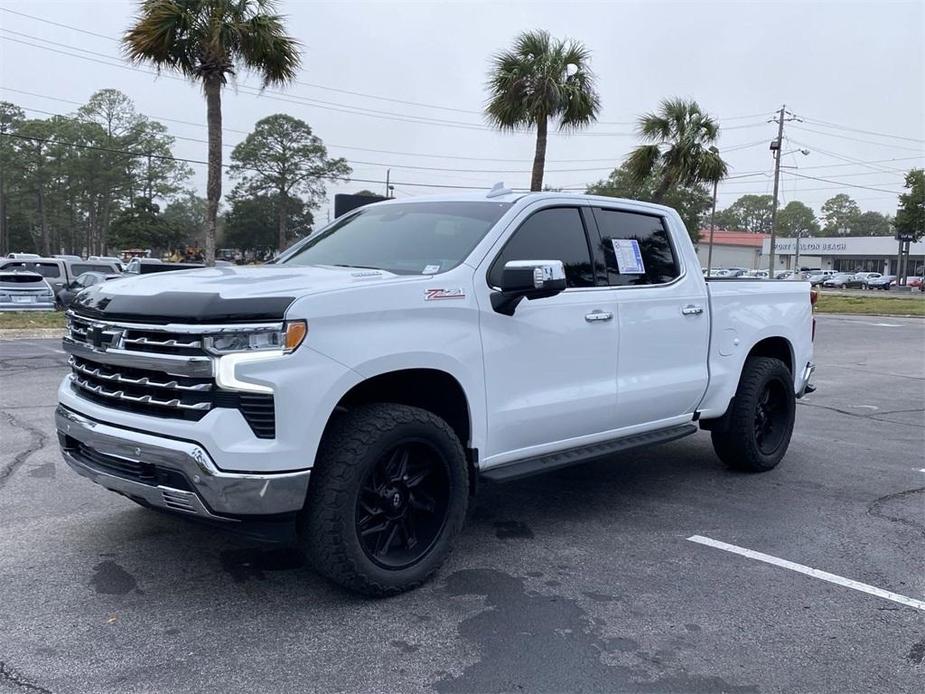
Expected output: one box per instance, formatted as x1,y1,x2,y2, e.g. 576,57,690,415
481,424,697,482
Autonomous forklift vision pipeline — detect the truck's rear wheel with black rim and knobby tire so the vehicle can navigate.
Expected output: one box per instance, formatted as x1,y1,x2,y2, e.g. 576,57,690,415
711,357,796,472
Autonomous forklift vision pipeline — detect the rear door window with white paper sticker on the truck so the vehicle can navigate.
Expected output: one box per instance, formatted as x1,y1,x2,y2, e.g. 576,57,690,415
594,212,680,287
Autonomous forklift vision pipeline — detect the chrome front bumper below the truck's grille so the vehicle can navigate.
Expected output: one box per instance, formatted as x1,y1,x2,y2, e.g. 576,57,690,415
55,405,309,523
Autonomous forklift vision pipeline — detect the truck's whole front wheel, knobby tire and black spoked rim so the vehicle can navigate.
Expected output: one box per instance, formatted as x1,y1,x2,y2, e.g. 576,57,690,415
300,403,469,597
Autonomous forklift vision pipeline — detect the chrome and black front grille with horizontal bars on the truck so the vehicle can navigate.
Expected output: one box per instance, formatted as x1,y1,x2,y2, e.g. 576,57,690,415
63,312,276,438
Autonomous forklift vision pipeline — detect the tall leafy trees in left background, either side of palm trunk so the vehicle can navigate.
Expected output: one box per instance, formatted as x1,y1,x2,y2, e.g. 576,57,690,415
0,89,350,255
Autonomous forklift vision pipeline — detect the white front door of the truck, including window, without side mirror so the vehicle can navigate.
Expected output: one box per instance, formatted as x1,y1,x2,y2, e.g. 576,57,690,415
475,206,618,467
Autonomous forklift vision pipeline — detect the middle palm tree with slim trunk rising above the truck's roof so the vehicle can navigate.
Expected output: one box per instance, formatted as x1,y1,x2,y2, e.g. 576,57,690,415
485,30,601,191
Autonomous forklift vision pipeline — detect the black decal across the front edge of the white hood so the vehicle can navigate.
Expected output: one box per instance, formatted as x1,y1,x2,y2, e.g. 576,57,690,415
71,285,295,324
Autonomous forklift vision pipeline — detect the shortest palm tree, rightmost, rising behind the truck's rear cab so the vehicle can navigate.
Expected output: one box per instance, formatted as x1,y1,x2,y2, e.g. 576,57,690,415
626,99,727,202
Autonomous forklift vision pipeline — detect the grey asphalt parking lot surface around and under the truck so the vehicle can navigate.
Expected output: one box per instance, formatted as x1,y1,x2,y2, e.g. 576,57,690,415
0,316,925,693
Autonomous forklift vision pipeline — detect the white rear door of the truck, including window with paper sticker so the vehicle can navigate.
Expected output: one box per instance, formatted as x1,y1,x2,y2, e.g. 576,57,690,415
591,205,710,428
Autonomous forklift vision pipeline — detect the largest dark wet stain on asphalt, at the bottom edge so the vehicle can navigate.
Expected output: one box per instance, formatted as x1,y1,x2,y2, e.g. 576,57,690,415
433,569,757,692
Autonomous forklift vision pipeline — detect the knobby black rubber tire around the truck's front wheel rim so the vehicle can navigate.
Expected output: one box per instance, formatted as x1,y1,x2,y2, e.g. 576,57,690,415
299,403,469,597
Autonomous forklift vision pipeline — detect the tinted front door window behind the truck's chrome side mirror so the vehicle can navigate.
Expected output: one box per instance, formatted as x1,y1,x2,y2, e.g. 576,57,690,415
488,207,594,287
